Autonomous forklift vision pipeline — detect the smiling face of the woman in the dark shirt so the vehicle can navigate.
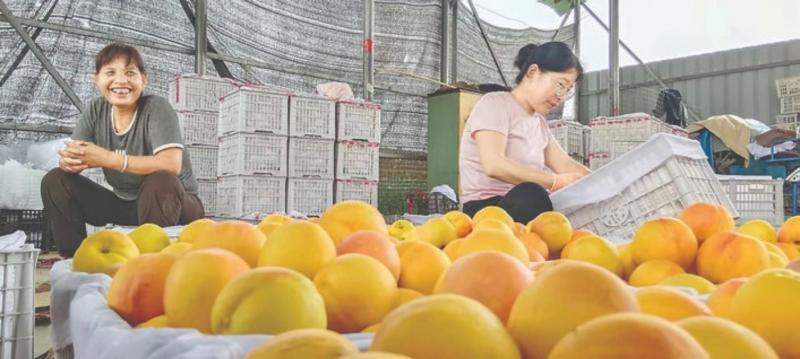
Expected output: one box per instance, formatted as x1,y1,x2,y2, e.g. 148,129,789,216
95,56,147,108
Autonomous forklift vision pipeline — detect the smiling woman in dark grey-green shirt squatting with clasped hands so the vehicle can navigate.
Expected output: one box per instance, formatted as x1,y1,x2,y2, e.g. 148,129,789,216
42,43,203,257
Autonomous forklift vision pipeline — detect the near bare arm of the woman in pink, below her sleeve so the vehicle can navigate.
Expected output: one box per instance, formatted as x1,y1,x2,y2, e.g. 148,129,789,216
475,130,555,189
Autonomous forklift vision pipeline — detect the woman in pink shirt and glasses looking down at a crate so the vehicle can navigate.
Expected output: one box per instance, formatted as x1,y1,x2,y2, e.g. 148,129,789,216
459,42,589,223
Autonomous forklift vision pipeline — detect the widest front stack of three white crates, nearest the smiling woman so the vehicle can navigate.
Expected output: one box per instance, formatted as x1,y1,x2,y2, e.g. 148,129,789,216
216,86,291,219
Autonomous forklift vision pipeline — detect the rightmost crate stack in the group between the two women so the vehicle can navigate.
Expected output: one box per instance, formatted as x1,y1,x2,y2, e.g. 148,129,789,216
334,101,381,207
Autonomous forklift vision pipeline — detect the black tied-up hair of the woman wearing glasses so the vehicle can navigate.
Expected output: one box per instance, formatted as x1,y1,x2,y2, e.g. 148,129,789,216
514,41,583,83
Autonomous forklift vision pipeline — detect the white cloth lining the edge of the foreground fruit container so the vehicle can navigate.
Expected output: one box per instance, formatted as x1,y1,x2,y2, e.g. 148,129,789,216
50,260,372,359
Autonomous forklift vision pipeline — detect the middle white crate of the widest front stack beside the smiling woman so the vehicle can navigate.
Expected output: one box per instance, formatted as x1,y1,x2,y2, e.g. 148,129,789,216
217,133,288,177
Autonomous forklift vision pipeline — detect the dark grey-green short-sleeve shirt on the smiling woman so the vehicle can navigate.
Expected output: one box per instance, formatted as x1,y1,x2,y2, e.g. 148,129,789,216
72,95,197,200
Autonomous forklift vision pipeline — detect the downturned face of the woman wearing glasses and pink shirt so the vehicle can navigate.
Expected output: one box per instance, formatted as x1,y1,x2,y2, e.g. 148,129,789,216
520,65,578,115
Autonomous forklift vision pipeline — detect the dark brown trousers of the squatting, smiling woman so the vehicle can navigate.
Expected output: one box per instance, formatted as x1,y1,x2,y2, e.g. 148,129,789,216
42,168,203,257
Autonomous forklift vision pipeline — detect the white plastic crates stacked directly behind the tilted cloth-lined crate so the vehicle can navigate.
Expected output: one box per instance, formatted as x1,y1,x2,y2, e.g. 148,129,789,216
589,113,688,170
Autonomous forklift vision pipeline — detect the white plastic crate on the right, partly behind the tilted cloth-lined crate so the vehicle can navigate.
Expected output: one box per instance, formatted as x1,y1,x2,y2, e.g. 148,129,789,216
717,175,783,226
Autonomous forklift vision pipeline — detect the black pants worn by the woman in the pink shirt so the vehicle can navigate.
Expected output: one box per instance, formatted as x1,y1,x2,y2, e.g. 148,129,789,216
463,182,553,224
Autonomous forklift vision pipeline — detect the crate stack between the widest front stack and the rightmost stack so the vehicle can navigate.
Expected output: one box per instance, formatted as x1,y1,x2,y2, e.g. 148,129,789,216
286,95,336,216
